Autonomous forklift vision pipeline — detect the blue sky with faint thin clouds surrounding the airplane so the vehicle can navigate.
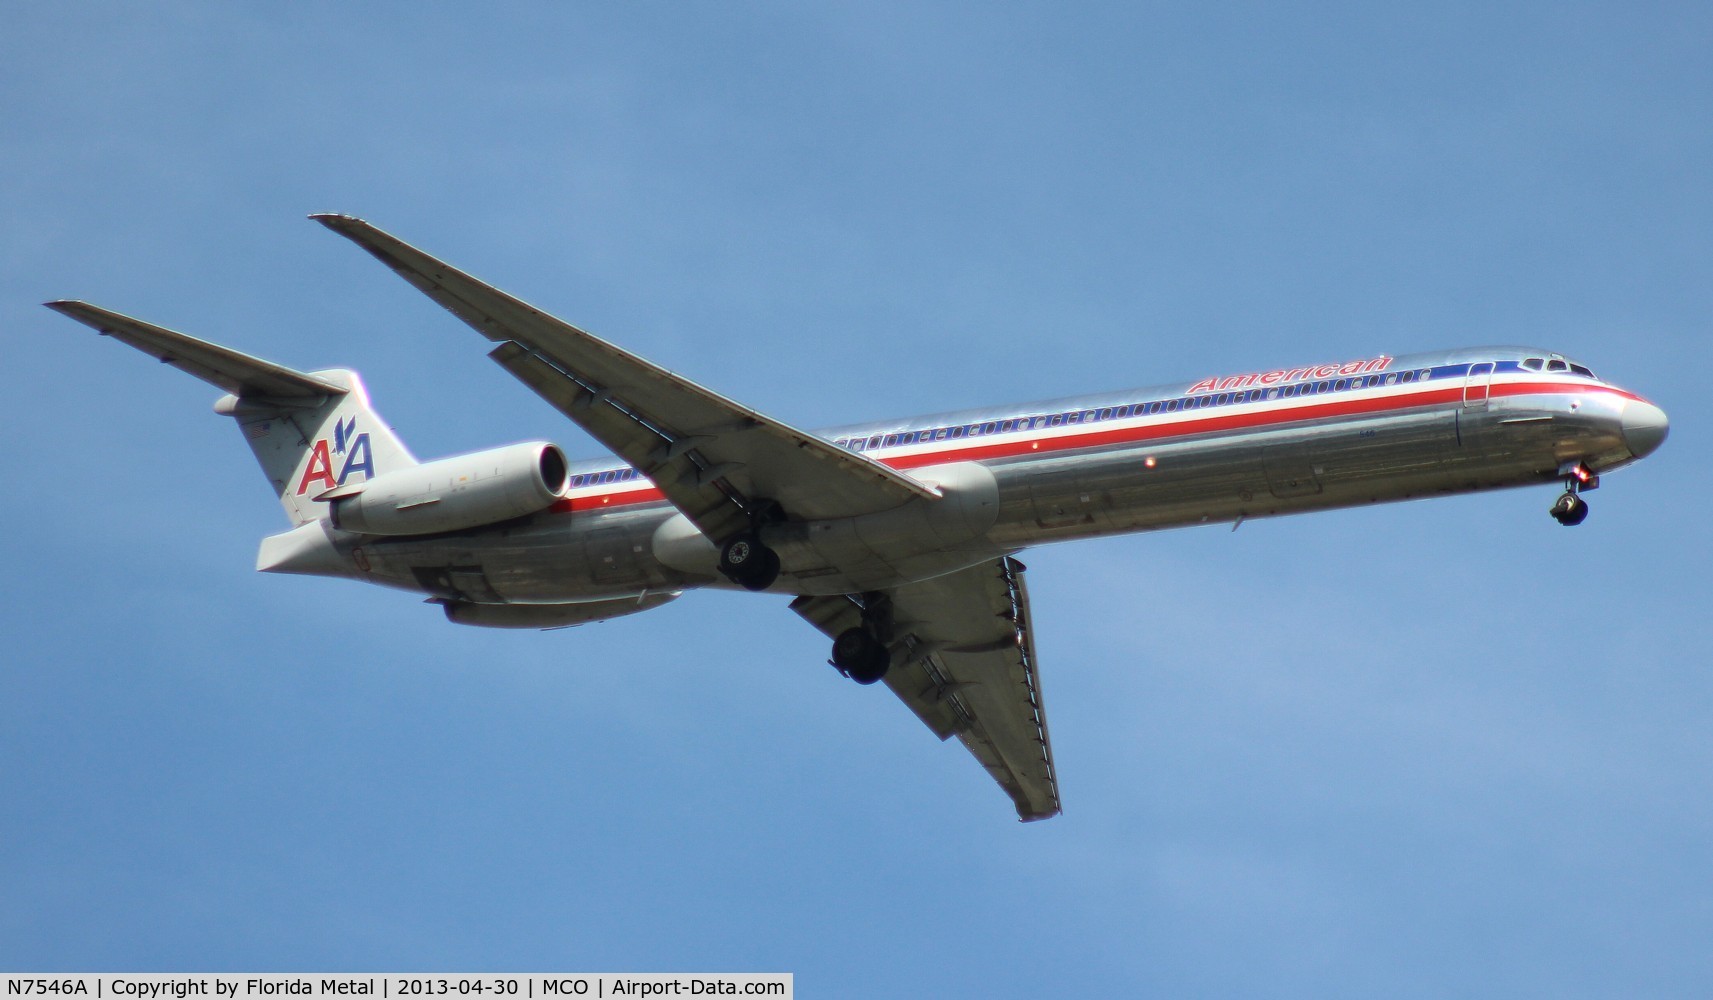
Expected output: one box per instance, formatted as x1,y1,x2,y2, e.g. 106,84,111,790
0,3,1713,997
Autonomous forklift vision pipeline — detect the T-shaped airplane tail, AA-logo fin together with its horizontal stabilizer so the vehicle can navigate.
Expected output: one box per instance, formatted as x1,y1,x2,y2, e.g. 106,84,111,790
46,301,416,524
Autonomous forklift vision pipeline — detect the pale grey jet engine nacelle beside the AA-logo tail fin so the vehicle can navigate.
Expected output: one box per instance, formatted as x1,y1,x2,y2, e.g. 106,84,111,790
330,442,567,534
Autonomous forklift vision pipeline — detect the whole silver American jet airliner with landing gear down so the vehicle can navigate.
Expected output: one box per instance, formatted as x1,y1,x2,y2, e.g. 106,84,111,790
48,216,1667,820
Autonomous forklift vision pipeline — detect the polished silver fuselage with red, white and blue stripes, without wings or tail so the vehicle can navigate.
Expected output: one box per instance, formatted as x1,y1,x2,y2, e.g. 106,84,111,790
336,348,1663,604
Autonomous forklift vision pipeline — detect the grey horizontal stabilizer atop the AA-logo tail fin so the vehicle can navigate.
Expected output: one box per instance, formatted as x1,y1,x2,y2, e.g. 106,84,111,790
43,300,346,399
